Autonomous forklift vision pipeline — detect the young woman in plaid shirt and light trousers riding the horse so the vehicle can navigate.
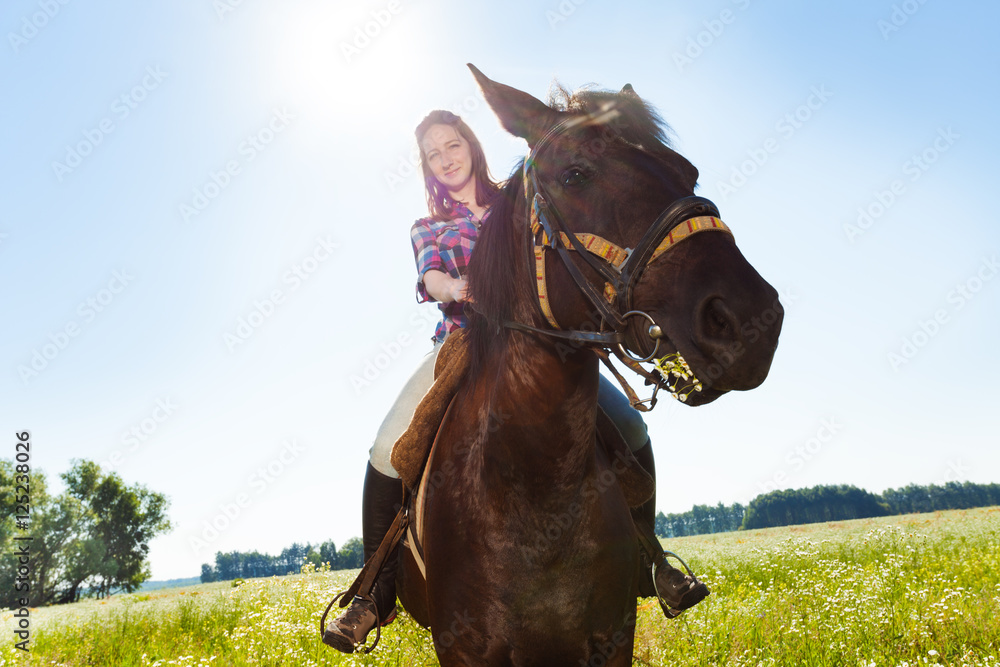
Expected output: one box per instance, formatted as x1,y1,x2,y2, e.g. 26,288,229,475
323,111,708,653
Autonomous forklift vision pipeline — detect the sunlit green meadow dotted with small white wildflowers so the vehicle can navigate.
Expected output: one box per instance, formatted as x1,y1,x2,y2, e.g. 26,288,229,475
0,508,1000,667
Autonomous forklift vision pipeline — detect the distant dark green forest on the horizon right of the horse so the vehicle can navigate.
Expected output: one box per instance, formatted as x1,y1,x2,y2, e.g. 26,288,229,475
656,482,1000,537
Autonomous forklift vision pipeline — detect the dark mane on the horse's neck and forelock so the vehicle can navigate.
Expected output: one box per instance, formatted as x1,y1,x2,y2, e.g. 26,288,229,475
466,86,672,377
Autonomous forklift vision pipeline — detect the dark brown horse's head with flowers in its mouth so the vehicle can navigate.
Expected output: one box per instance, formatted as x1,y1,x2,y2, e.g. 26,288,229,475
470,65,783,405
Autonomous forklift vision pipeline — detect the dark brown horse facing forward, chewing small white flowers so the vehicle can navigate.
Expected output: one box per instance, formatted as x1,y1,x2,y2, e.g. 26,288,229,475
399,66,782,667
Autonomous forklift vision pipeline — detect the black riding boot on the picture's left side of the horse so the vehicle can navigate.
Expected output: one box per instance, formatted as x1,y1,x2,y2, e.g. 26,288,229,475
323,463,403,653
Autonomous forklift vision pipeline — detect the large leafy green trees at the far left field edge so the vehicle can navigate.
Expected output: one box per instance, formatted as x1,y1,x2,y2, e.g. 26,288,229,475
0,459,170,608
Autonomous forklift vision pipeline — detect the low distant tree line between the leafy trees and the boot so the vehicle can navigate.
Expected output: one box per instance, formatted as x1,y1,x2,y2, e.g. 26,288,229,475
201,537,365,584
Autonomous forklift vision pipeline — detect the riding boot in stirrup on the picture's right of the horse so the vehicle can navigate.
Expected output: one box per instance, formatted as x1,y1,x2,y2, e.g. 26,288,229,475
632,440,709,618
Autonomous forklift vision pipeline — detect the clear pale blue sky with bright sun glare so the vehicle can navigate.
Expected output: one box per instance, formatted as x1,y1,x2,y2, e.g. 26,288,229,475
0,0,1000,579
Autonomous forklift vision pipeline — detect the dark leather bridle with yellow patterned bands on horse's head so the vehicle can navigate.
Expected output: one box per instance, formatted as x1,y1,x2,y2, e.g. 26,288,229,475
504,109,732,377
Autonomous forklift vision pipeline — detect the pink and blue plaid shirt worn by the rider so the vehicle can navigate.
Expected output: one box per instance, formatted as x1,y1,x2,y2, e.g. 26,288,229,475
410,204,489,341
